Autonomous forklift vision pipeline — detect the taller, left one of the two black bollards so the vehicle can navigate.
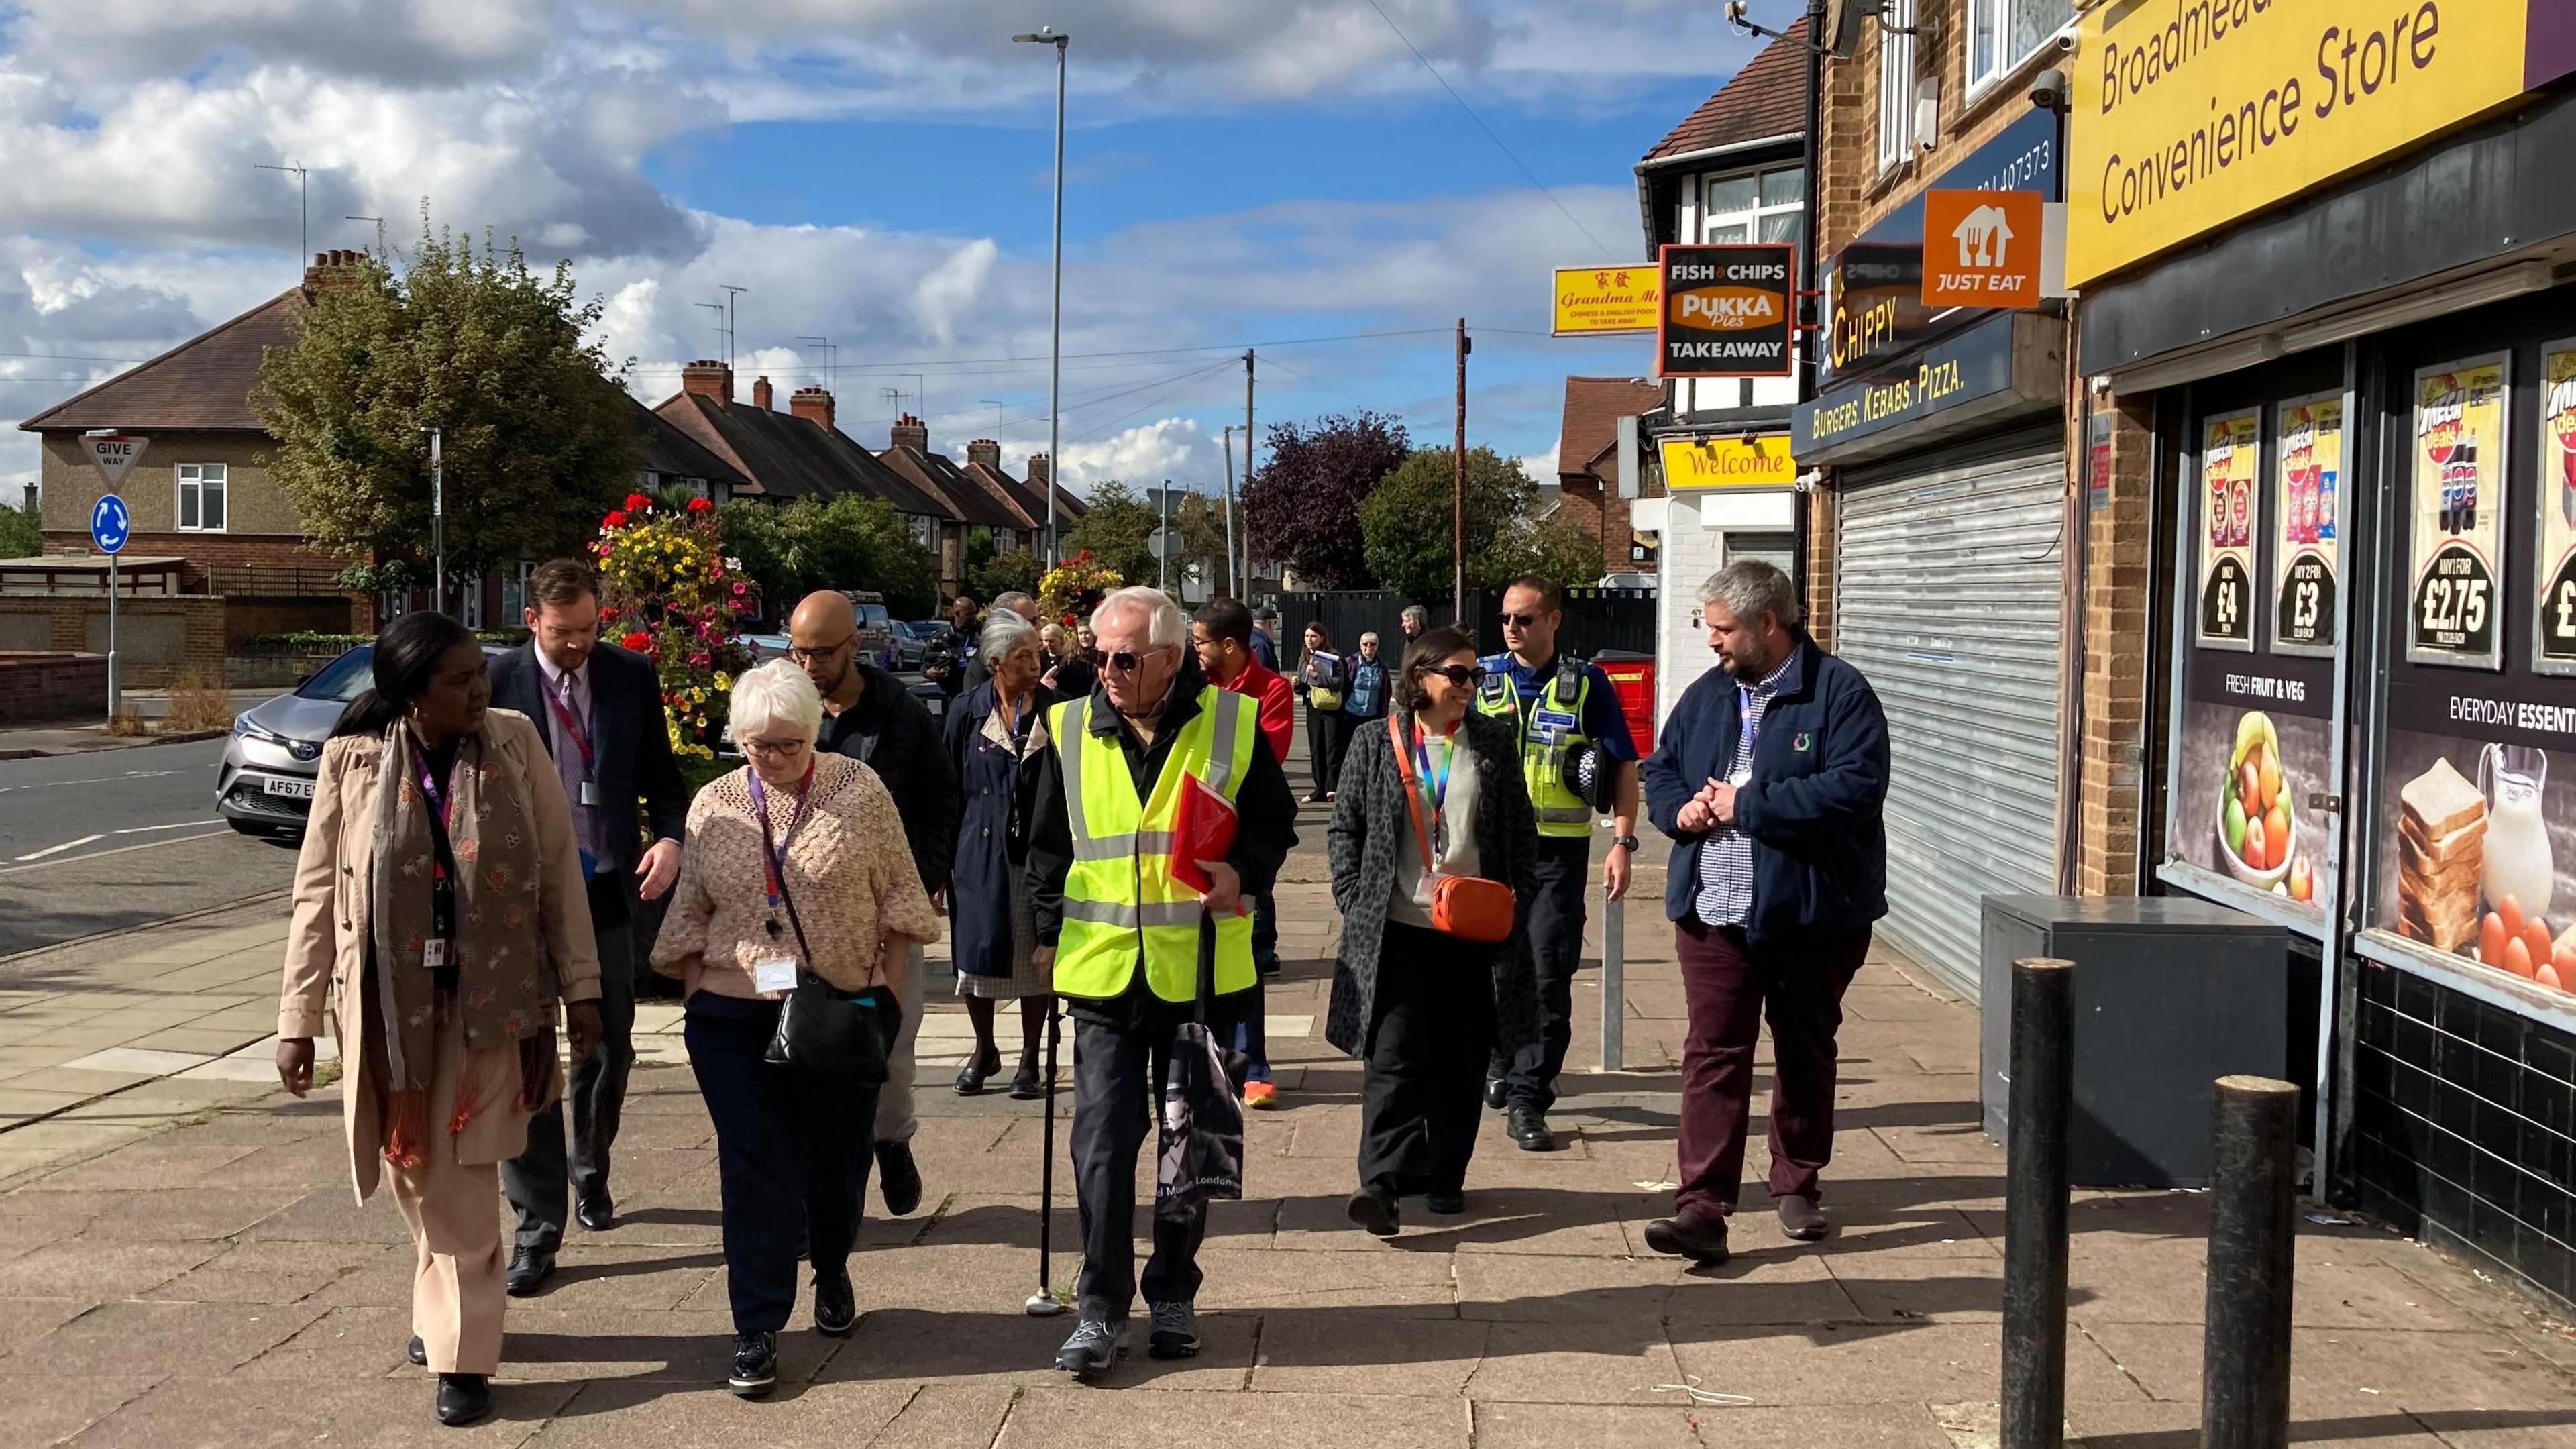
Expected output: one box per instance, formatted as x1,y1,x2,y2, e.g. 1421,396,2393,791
2002,957,2076,1449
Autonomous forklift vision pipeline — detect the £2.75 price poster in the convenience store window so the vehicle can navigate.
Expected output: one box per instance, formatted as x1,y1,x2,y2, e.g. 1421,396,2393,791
2406,354,2506,670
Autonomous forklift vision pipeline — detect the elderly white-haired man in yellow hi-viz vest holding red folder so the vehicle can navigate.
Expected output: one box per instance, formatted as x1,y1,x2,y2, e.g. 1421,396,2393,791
1028,588,1296,1379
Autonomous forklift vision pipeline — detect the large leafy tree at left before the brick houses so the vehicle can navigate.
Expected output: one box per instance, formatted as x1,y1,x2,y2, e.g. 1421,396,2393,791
260,217,639,588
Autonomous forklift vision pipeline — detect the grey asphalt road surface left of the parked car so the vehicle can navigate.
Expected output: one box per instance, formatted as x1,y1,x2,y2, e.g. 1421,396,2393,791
0,740,297,959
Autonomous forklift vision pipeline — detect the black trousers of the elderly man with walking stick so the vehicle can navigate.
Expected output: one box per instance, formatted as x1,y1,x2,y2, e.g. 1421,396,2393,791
1071,1008,1224,1323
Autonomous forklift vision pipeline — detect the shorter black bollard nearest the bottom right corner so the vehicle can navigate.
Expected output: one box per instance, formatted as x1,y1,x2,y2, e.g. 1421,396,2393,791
2200,1078,2298,1449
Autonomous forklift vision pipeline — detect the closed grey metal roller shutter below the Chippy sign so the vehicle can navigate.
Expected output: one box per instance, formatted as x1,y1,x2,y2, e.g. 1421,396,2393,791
1834,451,2066,1000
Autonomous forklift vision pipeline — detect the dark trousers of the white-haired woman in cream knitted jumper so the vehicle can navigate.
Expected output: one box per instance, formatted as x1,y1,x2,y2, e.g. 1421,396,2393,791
683,990,876,1333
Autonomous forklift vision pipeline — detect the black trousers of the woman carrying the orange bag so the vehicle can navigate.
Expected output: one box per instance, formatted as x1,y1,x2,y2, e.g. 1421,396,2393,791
1360,920,1494,1196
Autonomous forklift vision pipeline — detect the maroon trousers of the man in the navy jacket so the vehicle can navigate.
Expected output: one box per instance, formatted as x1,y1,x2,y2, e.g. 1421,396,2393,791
1674,920,1870,1217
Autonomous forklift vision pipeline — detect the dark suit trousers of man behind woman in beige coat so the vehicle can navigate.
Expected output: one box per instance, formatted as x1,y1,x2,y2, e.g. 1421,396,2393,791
500,871,636,1253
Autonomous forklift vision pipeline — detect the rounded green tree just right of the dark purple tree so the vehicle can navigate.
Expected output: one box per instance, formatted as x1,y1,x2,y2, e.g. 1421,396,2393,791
1360,449,1556,598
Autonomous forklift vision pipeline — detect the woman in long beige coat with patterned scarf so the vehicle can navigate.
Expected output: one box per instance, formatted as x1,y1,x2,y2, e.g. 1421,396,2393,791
278,614,600,1424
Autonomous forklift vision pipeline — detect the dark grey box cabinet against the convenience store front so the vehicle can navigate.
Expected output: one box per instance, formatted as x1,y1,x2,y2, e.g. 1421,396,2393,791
1976,895,2290,1189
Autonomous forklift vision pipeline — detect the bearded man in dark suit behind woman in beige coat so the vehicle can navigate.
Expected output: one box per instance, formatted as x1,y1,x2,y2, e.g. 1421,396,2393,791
492,559,688,1297
